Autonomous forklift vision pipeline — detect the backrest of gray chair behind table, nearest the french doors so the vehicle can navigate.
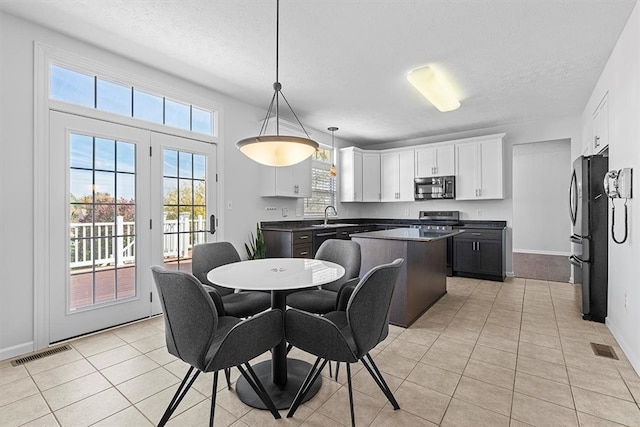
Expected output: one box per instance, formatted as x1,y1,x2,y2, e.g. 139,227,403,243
191,242,240,295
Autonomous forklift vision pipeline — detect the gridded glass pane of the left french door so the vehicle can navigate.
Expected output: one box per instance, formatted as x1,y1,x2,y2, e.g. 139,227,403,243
68,133,136,311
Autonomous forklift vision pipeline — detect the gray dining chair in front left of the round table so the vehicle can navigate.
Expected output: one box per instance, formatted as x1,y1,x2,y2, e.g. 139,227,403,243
151,266,283,426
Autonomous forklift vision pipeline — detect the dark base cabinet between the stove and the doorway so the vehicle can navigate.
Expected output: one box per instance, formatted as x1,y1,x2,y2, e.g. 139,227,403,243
453,229,505,281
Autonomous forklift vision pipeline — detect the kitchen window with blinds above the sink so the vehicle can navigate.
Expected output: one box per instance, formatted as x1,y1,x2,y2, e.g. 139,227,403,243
304,146,336,216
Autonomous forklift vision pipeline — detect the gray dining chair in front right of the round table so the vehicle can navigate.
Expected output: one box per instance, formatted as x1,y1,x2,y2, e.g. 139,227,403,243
285,258,404,426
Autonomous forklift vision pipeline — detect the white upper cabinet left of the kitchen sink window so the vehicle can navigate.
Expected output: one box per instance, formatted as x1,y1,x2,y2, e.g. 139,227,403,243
260,158,311,197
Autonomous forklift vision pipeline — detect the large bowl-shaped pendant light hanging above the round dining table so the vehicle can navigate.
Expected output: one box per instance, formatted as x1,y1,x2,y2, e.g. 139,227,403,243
236,0,319,166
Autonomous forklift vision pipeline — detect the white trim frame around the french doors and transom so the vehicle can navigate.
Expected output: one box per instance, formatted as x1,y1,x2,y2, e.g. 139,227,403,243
34,41,225,353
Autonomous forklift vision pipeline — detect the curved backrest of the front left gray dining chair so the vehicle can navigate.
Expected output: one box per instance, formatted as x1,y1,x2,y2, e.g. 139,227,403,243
151,266,218,370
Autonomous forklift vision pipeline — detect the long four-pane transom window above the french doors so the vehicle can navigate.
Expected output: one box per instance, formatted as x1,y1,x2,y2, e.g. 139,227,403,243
49,64,214,135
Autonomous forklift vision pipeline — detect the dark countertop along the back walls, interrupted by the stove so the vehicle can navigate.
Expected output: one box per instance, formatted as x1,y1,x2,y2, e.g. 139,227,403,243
261,218,507,232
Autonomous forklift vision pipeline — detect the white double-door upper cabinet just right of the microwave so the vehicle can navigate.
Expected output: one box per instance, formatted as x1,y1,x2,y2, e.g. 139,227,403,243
455,134,504,200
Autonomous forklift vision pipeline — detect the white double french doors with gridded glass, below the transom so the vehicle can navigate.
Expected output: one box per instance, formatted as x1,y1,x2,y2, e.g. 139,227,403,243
49,111,216,342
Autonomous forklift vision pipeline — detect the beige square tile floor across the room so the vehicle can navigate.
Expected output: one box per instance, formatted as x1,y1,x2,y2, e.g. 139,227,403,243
0,278,640,427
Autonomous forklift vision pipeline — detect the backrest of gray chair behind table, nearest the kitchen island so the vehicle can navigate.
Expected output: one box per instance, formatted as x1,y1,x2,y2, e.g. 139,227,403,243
315,239,362,292
